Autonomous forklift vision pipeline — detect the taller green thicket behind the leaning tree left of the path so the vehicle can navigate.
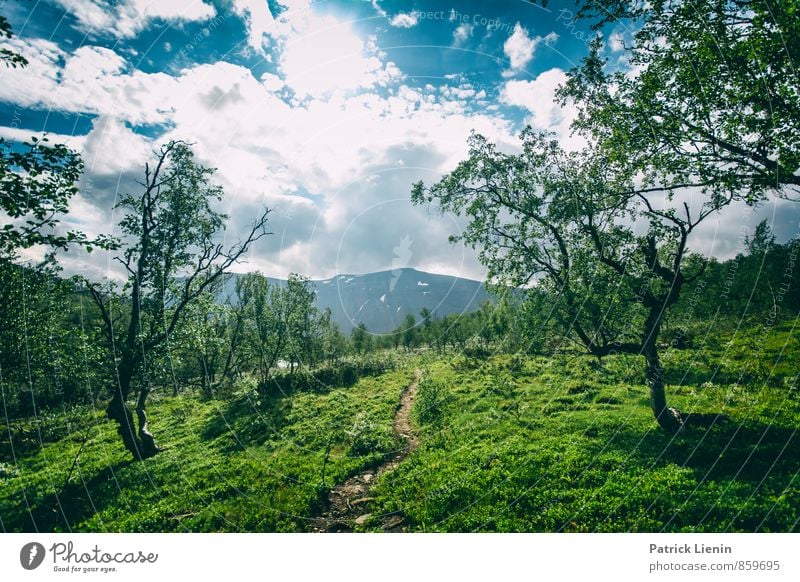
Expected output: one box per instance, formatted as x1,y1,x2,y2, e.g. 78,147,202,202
0,259,376,417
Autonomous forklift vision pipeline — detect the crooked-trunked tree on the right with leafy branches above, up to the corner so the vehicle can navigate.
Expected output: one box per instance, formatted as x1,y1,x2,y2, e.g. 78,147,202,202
412,0,800,432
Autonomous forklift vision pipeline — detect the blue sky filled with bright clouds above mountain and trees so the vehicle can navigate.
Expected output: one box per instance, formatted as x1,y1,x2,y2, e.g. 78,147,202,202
0,0,800,279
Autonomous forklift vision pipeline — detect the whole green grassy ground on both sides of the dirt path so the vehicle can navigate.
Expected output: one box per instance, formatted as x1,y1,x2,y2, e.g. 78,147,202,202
0,326,800,532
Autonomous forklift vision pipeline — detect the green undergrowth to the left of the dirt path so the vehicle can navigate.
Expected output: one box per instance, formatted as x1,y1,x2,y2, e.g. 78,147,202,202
0,370,411,532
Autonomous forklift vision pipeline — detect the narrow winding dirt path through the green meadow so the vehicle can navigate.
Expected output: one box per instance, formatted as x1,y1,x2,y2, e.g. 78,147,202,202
309,370,422,532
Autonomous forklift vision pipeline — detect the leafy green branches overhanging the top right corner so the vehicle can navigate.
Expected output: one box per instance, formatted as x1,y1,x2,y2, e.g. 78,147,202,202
559,0,800,203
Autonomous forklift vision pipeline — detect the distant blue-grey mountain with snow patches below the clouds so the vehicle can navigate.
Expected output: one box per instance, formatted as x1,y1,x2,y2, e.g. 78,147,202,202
224,268,491,334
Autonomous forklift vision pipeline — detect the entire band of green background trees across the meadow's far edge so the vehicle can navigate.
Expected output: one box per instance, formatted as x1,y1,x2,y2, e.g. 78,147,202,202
0,223,800,416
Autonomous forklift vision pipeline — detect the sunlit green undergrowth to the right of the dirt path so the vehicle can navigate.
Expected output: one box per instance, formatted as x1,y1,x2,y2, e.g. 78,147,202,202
373,326,800,532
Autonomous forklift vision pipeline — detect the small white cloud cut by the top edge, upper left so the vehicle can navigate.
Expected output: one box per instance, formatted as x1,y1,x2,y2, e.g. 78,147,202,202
55,0,216,38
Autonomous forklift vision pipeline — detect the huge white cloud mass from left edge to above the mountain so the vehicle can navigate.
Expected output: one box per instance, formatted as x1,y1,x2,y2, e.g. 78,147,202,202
0,32,514,278
